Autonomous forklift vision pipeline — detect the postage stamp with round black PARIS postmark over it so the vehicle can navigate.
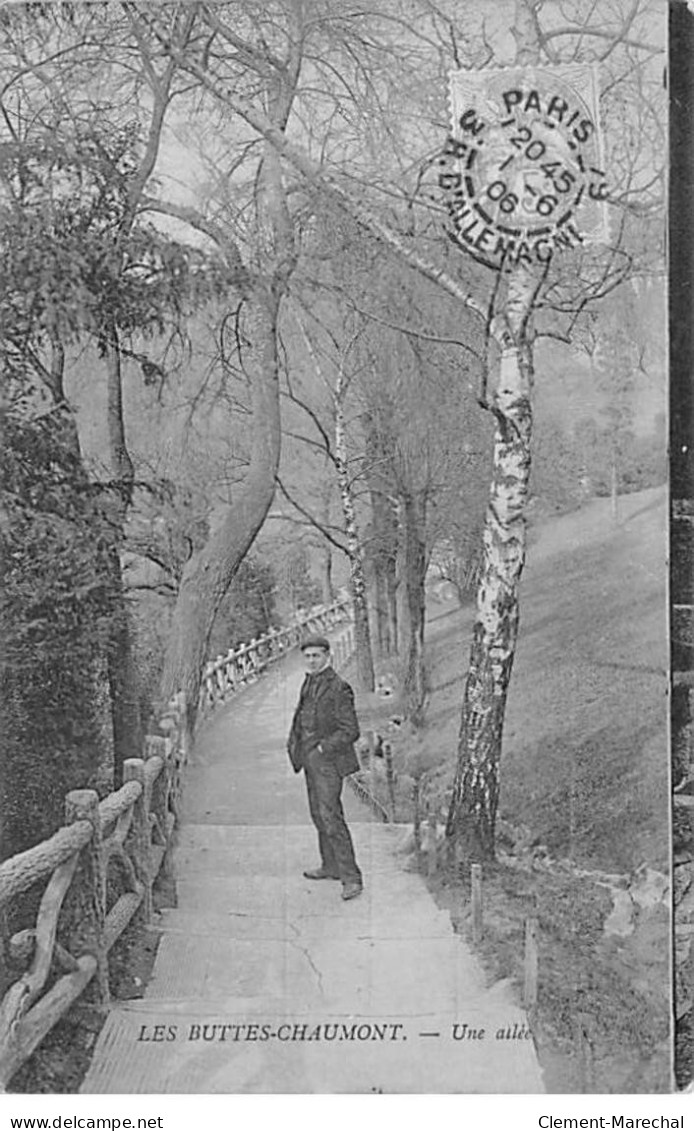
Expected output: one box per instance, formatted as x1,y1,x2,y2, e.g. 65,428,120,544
439,68,607,267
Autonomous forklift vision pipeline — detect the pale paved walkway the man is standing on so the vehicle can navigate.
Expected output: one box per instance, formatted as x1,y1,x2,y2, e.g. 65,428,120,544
81,656,544,1094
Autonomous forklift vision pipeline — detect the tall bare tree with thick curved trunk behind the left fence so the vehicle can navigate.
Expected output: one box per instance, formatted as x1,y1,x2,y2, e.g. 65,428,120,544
128,5,309,728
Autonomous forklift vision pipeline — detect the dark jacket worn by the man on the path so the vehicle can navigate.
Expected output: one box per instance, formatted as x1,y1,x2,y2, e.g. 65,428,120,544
287,667,359,777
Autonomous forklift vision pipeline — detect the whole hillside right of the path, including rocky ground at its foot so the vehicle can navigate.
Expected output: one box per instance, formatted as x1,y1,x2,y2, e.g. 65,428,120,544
361,489,671,1093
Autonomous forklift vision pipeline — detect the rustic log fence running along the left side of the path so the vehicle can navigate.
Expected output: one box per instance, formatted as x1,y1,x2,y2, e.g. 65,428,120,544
0,601,354,1090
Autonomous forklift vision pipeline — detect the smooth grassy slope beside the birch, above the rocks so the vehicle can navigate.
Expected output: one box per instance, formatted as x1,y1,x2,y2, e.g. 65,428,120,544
425,489,668,871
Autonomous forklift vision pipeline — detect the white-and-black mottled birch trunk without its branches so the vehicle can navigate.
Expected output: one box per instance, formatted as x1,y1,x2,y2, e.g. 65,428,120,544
446,268,535,862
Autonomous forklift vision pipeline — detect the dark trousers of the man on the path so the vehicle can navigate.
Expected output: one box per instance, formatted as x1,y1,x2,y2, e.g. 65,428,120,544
303,750,362,883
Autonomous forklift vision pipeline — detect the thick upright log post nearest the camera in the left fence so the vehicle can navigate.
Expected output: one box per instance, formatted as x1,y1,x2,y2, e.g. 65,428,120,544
66,789,111,1005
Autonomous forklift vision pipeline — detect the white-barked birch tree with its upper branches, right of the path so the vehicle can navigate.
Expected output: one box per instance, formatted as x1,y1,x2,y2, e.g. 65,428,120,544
446,0,669,860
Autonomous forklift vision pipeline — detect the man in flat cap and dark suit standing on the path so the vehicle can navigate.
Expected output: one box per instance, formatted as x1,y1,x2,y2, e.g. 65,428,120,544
287,636,363,899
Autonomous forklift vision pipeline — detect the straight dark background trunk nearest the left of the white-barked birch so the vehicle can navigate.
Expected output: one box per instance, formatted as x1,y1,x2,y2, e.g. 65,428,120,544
401,492,426,726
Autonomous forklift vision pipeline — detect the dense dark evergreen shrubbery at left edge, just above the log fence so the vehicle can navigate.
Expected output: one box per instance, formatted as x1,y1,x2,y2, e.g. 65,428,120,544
0,414,113,858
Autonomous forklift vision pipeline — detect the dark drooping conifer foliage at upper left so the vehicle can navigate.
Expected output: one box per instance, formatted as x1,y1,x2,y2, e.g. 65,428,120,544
0,124,224,361
